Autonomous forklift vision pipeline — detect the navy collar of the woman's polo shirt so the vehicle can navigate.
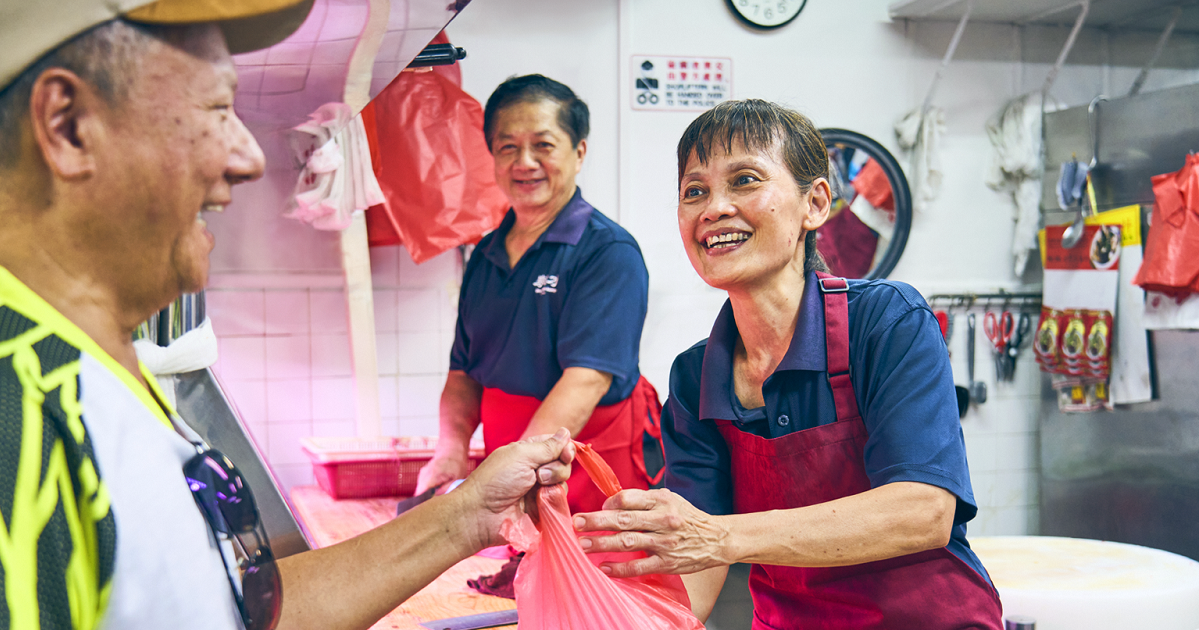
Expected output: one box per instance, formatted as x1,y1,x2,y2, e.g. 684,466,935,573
699,272,829,420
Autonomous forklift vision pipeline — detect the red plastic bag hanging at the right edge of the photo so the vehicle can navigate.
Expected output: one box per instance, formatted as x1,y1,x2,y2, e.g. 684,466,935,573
1133,154,1199,298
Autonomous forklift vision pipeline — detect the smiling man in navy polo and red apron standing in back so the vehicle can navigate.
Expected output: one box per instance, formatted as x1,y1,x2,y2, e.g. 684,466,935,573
416,74,661,511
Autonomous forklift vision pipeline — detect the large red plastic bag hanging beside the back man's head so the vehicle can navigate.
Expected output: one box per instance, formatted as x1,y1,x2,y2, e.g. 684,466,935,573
362,34,508,263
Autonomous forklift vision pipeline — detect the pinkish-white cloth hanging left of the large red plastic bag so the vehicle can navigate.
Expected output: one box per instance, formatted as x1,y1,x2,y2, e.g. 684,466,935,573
285,103,384,230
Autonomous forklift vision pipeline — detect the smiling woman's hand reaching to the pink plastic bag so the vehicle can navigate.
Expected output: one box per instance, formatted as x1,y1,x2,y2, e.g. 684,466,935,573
574,490,735,577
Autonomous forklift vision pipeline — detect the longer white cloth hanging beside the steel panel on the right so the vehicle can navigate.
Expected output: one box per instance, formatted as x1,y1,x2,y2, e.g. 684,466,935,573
987,92,1044,276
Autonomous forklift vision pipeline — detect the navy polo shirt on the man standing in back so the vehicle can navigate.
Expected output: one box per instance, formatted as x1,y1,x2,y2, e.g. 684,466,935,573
450,188,650,404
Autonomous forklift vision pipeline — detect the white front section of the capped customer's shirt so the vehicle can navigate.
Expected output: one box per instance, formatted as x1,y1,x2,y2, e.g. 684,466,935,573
79,352,242,630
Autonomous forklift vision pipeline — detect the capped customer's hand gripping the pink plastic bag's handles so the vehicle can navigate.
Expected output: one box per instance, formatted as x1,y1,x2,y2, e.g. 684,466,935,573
447,428,574,548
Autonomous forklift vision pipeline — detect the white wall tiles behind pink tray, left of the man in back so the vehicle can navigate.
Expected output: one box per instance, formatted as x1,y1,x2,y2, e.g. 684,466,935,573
207,247,462,490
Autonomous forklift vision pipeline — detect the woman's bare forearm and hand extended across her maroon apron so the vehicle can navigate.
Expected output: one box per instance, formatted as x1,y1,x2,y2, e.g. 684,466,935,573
574,481,957,577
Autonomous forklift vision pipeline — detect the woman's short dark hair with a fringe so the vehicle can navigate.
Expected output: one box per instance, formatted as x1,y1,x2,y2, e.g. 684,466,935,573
679,98,829,271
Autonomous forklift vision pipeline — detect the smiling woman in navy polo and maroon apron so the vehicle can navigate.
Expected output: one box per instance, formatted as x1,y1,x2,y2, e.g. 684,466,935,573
576,101,1001,630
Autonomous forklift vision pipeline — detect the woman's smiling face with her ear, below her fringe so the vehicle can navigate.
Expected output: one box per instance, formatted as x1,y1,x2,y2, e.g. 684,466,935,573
679,142,830,290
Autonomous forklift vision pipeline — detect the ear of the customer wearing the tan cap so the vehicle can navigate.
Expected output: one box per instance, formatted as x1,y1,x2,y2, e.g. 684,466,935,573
29,67,106,181
